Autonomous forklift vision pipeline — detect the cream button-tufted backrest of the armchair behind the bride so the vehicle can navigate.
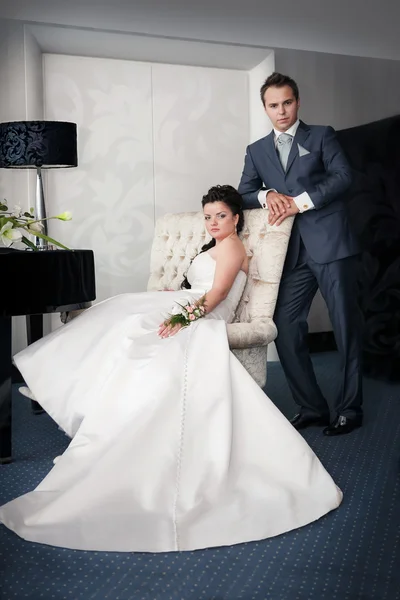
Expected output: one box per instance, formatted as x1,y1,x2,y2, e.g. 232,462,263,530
148,209,293,330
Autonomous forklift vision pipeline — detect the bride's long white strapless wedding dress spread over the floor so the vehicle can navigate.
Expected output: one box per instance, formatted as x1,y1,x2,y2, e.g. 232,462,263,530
0,253,342,552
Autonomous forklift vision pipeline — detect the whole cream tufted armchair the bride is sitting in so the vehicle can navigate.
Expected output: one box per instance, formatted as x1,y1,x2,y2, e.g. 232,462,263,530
147,209,293,387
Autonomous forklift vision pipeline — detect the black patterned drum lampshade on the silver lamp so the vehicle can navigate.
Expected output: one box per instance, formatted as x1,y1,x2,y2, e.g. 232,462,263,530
0,121,78,169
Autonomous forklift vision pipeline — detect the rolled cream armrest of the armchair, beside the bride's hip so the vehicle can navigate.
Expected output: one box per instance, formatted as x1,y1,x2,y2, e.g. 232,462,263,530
227,319,278,349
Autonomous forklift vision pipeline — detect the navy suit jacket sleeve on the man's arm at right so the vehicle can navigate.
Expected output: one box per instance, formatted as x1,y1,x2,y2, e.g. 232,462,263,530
306,127,352,210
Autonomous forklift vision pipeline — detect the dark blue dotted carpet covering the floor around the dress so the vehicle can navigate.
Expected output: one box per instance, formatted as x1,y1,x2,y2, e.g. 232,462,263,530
0,353,400,600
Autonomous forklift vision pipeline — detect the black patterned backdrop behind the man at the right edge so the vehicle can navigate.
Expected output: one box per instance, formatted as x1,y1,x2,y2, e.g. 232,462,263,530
338,116,400,381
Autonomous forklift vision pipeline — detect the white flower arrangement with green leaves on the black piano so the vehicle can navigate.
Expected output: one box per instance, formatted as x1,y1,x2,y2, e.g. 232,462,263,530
0,200,72,250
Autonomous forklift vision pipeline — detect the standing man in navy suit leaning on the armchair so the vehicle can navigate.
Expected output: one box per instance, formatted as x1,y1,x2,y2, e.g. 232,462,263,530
239,73,362,436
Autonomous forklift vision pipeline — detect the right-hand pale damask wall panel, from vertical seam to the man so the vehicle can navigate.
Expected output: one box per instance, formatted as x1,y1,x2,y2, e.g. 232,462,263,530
152,65,249,217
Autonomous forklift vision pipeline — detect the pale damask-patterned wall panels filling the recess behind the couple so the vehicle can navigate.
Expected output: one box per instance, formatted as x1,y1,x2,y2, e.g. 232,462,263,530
44,55,249,300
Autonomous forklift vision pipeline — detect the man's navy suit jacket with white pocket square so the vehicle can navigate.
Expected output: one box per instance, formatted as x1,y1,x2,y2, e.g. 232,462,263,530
239,121,359,267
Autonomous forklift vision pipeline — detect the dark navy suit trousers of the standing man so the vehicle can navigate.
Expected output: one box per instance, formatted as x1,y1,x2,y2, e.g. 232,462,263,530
274,243,362,418
